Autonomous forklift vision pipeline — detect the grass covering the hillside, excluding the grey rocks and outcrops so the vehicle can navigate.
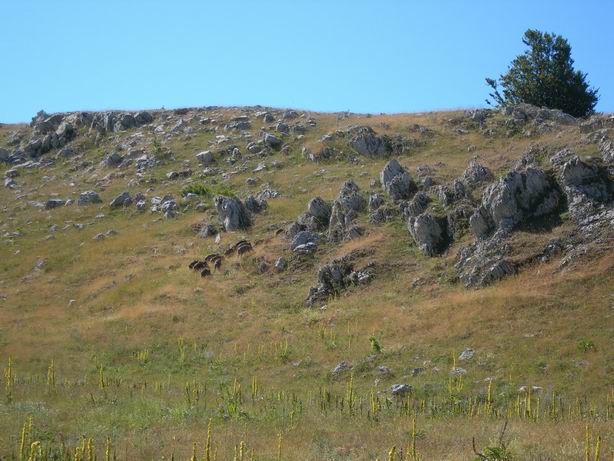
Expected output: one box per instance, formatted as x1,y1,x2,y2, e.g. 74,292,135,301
0,108,614,461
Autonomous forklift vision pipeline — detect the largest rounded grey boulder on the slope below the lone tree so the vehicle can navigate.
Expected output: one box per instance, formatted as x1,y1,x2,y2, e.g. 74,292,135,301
470,167,561,238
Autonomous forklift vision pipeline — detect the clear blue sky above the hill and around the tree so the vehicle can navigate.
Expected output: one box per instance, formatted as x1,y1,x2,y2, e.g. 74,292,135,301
0,0,614,123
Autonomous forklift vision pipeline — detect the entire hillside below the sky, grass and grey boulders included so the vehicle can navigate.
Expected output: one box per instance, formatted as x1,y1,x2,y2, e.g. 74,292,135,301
0,102,614,461
